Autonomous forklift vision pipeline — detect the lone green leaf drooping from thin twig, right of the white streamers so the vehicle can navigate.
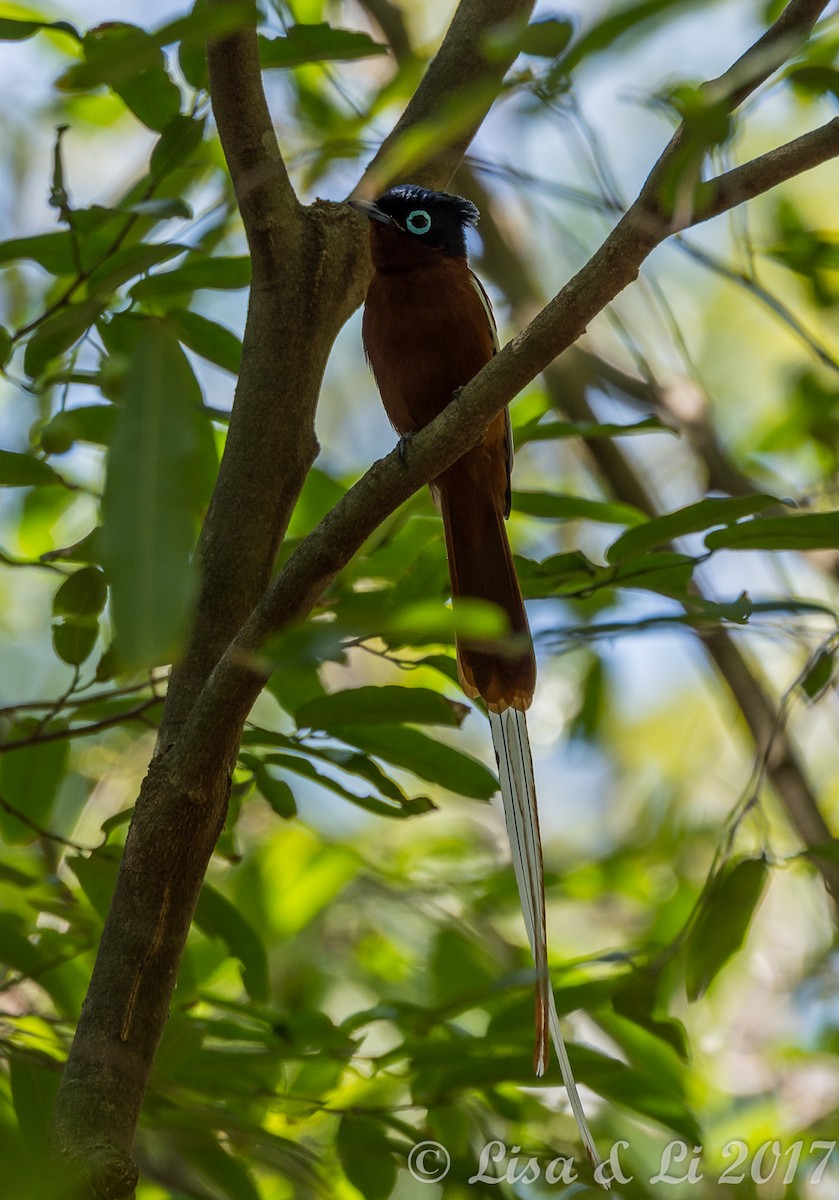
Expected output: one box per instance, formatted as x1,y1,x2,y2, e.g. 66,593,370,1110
685,858,768,1001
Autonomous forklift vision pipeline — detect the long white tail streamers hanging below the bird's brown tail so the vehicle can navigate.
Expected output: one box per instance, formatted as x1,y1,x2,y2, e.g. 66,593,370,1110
489,708,600,1168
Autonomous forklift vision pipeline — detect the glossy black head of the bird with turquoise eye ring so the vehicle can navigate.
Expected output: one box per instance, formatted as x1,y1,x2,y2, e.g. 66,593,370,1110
349,184,479,258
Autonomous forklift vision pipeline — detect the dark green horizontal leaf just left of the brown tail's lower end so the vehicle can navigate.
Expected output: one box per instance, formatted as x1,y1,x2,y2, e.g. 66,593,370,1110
296,685,469,732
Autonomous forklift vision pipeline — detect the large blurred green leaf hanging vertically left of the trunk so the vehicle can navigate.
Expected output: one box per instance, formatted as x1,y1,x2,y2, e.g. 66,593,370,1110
101,320,204,671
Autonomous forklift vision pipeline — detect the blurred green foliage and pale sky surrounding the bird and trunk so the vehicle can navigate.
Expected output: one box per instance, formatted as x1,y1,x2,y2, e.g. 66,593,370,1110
0,0,839,1200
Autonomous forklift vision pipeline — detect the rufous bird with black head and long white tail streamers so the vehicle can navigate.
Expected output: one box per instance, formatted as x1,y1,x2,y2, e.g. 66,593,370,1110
349,184,600,1166
